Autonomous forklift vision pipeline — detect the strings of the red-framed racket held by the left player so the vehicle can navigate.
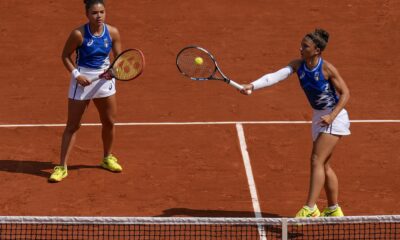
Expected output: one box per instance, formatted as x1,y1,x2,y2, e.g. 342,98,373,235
113,50,144,80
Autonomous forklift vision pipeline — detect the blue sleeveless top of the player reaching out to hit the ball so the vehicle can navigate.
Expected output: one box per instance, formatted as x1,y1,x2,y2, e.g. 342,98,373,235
297,58,339,110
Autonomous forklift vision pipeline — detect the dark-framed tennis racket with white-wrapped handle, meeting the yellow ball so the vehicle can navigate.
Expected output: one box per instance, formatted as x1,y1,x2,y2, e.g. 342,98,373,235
176,46,243,90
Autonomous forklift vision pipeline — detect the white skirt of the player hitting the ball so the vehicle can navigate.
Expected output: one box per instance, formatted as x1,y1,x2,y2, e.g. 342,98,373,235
312,109,350,141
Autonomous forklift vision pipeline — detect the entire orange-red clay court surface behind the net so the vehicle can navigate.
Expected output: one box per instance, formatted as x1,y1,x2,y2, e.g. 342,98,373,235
0,0,400,217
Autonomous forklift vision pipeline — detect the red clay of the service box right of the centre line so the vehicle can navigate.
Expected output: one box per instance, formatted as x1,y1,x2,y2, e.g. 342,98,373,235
245,123,400,216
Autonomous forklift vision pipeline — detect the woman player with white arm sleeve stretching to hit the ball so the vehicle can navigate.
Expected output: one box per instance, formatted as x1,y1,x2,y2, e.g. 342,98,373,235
241,29,350,217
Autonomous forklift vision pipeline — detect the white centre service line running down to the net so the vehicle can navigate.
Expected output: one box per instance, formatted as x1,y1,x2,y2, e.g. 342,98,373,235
236,123,267,240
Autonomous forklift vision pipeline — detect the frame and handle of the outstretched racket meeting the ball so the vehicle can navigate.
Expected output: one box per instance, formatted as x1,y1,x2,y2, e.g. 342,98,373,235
176,45,243,90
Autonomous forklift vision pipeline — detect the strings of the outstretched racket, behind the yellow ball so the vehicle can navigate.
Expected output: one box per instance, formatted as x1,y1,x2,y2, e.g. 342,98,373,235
177,48,216,78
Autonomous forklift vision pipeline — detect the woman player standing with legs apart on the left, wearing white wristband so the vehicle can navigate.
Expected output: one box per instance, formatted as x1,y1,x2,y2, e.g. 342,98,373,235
49,0,122,182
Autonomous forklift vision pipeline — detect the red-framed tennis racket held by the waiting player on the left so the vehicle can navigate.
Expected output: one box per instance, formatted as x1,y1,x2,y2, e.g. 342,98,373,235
91,49,145,82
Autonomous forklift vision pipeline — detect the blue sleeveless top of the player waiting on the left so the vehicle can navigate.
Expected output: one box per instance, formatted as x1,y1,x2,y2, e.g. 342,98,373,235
76,23,112,69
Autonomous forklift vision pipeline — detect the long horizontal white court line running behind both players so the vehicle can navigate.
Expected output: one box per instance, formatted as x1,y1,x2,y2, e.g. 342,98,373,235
0,120,400,128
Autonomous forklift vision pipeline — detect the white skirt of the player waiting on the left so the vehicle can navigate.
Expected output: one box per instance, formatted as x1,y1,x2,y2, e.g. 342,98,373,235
68,67,116,100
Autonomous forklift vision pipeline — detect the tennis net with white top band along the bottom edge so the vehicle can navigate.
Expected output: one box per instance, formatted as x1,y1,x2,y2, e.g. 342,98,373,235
0,215,400,240
